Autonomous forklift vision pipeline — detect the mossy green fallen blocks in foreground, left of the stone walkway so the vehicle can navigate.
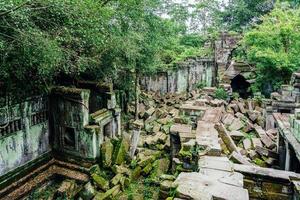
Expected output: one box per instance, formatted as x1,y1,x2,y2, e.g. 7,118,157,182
50,133,170,200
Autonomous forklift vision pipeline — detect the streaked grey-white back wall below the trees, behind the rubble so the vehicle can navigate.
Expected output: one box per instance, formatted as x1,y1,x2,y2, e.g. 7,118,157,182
140,58,216,94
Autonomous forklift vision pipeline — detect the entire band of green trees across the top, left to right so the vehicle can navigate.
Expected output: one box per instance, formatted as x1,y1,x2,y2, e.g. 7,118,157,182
0,0,300,97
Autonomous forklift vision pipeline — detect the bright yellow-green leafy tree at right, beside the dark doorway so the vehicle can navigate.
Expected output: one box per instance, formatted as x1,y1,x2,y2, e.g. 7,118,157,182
242,6,300,93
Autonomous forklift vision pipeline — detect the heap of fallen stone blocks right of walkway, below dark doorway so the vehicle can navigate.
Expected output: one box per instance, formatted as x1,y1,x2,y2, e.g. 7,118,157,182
218,99,278,167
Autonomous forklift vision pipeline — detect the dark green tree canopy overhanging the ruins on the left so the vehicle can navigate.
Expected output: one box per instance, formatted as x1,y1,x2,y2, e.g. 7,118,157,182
0,0,203,99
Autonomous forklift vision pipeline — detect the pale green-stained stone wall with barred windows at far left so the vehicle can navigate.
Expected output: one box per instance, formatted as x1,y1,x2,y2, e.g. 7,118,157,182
0,96,50,176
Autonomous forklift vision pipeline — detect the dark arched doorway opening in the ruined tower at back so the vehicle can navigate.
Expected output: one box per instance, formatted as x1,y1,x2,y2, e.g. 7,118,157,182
231,74,251,99
